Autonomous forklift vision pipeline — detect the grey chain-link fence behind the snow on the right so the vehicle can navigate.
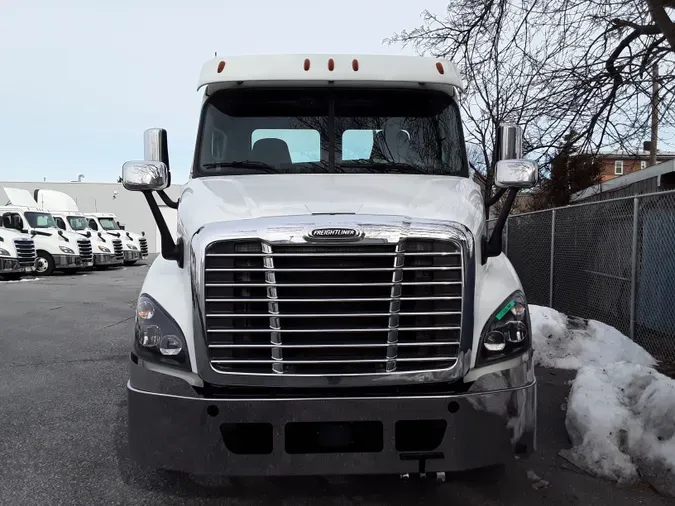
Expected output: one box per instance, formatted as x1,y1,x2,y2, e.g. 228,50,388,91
488,191,675,367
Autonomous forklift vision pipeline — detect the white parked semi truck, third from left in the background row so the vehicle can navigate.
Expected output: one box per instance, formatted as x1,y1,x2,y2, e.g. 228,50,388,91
33,188,124,269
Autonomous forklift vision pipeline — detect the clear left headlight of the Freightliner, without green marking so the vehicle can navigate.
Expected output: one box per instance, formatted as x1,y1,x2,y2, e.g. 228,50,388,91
134,294,190,370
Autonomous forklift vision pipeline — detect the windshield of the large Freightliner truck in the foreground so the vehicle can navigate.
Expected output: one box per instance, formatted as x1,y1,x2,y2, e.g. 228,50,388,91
193,89,468,177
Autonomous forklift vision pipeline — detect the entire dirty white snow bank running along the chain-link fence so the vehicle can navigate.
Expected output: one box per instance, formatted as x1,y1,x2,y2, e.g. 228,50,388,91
530,306,675,496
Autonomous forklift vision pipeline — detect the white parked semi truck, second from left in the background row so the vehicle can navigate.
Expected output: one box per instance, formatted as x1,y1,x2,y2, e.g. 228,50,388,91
0,187,94,276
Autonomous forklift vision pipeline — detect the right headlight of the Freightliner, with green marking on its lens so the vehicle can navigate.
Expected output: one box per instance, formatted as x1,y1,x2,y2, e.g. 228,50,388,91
476,291,532,365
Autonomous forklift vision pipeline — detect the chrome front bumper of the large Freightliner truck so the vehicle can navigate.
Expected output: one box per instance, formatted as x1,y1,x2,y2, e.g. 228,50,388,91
127,363,537,476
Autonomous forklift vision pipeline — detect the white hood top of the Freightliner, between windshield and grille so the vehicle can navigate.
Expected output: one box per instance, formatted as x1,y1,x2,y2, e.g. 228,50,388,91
179,174,485,237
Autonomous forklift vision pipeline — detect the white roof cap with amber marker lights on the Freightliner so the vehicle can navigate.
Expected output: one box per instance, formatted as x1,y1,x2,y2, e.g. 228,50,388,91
197,54,464,94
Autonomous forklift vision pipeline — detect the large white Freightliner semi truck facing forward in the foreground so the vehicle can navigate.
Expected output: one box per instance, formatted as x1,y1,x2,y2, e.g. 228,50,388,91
122,55,538,475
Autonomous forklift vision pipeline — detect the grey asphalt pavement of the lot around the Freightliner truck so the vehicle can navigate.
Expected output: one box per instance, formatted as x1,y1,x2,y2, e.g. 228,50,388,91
0,264,672,506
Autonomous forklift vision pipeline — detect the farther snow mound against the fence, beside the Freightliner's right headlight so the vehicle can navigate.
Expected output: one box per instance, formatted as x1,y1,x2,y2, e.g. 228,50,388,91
530,305,656,369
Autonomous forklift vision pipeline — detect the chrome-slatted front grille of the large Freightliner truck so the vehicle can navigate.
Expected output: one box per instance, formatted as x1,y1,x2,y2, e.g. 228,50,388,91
204,238,464,375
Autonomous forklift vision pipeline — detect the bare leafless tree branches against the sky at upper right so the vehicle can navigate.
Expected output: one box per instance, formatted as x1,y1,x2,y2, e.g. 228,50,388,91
387,0,675,200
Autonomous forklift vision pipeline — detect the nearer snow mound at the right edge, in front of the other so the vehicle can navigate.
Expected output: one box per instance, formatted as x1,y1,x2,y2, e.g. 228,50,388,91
561,362,675,496
